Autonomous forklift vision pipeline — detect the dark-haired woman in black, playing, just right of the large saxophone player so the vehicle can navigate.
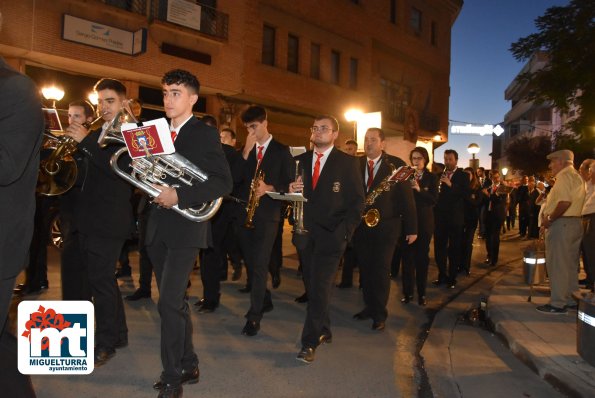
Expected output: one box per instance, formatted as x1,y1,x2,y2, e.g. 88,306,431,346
401,147,438,305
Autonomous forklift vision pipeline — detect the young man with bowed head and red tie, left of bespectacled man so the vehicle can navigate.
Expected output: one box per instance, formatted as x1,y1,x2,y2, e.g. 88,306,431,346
238,106,292,337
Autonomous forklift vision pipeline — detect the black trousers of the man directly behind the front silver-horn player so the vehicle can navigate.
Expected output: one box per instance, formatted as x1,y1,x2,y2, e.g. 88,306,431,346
78,233,128,350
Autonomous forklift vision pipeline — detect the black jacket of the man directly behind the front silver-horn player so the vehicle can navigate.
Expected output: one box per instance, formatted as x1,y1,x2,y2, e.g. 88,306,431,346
71,129,134,239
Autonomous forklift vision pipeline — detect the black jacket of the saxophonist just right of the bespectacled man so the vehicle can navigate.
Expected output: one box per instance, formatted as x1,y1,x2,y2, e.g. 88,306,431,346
359,152,417,235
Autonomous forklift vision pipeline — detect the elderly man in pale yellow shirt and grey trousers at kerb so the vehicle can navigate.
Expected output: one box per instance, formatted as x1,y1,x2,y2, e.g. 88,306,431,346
537,149,585,314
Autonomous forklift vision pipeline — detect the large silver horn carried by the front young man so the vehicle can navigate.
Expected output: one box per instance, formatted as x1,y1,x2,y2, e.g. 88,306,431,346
98,101,223,222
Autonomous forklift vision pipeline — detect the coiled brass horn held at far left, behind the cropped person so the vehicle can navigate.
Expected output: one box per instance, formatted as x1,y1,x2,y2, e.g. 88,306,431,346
36,116,103,196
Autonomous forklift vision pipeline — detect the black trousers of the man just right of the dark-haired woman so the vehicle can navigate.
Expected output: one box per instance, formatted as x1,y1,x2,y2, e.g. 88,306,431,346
434,213,463,283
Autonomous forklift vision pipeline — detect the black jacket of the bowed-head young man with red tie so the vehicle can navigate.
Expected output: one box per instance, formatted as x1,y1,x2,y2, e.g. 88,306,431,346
240,138,293,224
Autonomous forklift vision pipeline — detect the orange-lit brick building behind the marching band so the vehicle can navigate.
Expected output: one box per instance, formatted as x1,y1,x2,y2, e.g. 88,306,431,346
0,0,463,153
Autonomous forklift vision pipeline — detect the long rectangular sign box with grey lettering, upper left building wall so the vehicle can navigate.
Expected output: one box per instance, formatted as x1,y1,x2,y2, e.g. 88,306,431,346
62,14,147,55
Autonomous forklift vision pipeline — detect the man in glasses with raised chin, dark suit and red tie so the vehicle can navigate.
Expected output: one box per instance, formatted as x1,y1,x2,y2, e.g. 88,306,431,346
289,115,364,363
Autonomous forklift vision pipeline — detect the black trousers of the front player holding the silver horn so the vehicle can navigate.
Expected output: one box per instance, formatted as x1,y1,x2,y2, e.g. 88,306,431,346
147,236,199,386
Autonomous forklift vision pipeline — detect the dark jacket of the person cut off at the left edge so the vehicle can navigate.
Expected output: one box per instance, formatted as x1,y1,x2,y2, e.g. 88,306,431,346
0,57,44,280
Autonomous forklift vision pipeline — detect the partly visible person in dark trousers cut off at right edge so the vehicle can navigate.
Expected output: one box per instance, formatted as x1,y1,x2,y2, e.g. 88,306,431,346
581,159,595,290
